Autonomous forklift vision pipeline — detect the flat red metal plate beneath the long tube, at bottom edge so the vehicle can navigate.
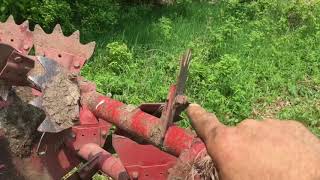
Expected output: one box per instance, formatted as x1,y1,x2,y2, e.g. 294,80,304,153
112,135,177,180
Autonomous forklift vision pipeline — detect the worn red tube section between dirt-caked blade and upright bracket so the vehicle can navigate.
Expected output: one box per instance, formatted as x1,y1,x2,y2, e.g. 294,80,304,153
87,92,163,145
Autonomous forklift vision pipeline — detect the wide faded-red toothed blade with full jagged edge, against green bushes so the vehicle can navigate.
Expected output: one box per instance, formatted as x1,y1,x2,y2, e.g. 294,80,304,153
33,24,95,72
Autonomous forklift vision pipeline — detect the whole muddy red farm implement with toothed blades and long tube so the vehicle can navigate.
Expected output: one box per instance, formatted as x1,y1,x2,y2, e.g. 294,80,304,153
0,17,214,180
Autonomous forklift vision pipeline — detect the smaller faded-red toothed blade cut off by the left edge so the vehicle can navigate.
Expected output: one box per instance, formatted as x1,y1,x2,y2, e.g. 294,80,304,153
0,16,33,55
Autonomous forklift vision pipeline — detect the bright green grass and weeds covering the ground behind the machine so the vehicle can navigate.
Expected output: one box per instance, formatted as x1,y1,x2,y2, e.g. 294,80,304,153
82,0,320,135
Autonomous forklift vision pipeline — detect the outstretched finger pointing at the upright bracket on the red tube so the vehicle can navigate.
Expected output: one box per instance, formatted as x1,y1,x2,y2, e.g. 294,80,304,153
187,104,225,142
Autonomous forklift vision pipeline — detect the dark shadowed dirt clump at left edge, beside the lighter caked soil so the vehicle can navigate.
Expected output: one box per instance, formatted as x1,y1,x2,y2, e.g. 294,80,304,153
0,91,45,157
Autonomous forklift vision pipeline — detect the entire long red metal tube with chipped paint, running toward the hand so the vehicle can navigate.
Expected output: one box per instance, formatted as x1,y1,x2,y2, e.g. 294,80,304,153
82,92,205,156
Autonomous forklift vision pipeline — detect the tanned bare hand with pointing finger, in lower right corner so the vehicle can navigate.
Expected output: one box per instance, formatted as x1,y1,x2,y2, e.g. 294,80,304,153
187,104,320,180
